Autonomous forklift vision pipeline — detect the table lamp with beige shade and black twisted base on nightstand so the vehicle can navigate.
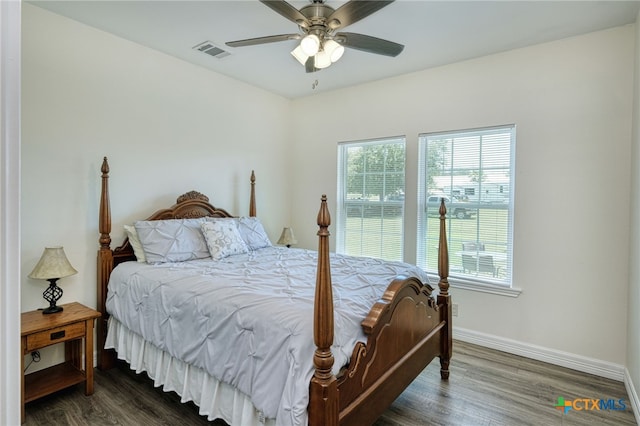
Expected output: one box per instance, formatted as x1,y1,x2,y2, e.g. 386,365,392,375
29,247,78,314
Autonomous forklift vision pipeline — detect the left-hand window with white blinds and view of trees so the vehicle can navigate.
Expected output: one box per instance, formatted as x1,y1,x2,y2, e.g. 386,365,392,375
336,137,405,260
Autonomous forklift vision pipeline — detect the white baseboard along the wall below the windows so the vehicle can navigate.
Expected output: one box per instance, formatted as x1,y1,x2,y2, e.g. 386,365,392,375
453,326,626,382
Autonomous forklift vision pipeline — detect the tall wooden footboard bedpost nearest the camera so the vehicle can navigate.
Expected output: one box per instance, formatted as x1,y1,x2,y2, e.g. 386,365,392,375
309,195,339,426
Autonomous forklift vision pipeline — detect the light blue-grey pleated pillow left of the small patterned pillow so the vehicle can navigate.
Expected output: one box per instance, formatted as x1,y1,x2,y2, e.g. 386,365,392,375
135,218,209,263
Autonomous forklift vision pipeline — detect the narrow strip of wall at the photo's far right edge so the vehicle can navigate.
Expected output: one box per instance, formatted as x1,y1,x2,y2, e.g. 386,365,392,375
627,6,640,412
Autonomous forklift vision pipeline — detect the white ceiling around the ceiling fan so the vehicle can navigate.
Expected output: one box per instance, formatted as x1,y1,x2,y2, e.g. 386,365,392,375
29,0,640,98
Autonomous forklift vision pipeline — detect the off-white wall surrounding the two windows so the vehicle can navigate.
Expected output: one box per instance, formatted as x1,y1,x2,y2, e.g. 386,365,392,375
291,25,634,365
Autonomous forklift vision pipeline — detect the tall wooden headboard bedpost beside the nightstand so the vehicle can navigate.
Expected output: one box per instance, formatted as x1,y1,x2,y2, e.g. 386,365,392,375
96,157,115,370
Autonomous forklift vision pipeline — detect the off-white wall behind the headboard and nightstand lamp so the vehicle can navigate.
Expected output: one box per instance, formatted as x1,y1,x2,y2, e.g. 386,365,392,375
21,4,290,366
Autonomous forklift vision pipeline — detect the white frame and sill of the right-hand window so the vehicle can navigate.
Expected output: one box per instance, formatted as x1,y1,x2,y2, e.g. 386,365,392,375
416,124,520,297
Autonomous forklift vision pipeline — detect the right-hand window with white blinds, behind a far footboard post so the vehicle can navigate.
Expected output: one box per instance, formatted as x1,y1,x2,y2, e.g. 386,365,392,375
417,126,515,286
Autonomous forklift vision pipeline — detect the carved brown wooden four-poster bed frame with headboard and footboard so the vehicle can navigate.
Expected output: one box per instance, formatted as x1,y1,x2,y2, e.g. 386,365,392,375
97,157,452,426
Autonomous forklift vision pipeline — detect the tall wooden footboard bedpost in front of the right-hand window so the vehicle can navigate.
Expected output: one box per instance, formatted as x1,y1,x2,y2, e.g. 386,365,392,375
438,198,453,380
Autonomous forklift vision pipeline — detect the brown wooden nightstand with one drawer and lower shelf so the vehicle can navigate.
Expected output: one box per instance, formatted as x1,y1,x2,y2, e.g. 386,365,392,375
21,303,100,422
